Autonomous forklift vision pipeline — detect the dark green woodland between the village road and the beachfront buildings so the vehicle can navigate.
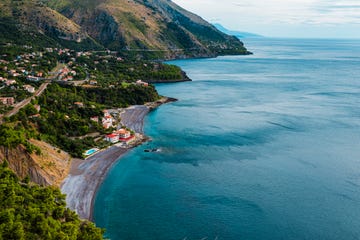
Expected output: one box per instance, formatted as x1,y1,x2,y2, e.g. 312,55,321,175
4,83,159,158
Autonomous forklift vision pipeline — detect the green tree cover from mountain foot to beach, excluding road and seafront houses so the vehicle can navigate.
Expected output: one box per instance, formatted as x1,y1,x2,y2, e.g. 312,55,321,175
0,42,183,158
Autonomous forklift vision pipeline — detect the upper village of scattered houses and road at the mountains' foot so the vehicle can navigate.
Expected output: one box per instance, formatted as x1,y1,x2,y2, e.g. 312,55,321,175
0,44,183,111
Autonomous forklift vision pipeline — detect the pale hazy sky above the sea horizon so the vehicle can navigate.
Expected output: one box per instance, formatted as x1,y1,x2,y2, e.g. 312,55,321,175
173,0,360,38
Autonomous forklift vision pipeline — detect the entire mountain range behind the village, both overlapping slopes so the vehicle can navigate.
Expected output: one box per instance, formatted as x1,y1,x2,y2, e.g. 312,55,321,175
0,0,249,59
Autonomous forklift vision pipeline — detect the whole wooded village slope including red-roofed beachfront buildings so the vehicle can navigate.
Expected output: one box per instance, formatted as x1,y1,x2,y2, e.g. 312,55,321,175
0,44,184,158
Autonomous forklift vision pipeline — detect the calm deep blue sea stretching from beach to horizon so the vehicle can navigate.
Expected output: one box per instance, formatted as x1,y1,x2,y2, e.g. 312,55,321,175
94,39,360,240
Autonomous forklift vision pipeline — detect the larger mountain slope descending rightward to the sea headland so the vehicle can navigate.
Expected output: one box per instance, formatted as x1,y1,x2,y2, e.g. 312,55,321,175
44,0,250,57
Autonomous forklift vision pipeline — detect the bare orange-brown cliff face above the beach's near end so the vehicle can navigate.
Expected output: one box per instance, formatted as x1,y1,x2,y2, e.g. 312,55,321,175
0,140,71,186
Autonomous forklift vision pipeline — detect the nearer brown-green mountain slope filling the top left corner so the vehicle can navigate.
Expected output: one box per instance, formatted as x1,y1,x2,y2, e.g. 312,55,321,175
0,0,100,48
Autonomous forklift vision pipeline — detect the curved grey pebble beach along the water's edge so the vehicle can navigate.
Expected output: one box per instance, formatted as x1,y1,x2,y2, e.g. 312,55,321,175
61,97,176,220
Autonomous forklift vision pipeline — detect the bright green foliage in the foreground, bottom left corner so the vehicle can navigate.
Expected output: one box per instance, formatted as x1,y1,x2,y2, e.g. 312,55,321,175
0,162,103,240
